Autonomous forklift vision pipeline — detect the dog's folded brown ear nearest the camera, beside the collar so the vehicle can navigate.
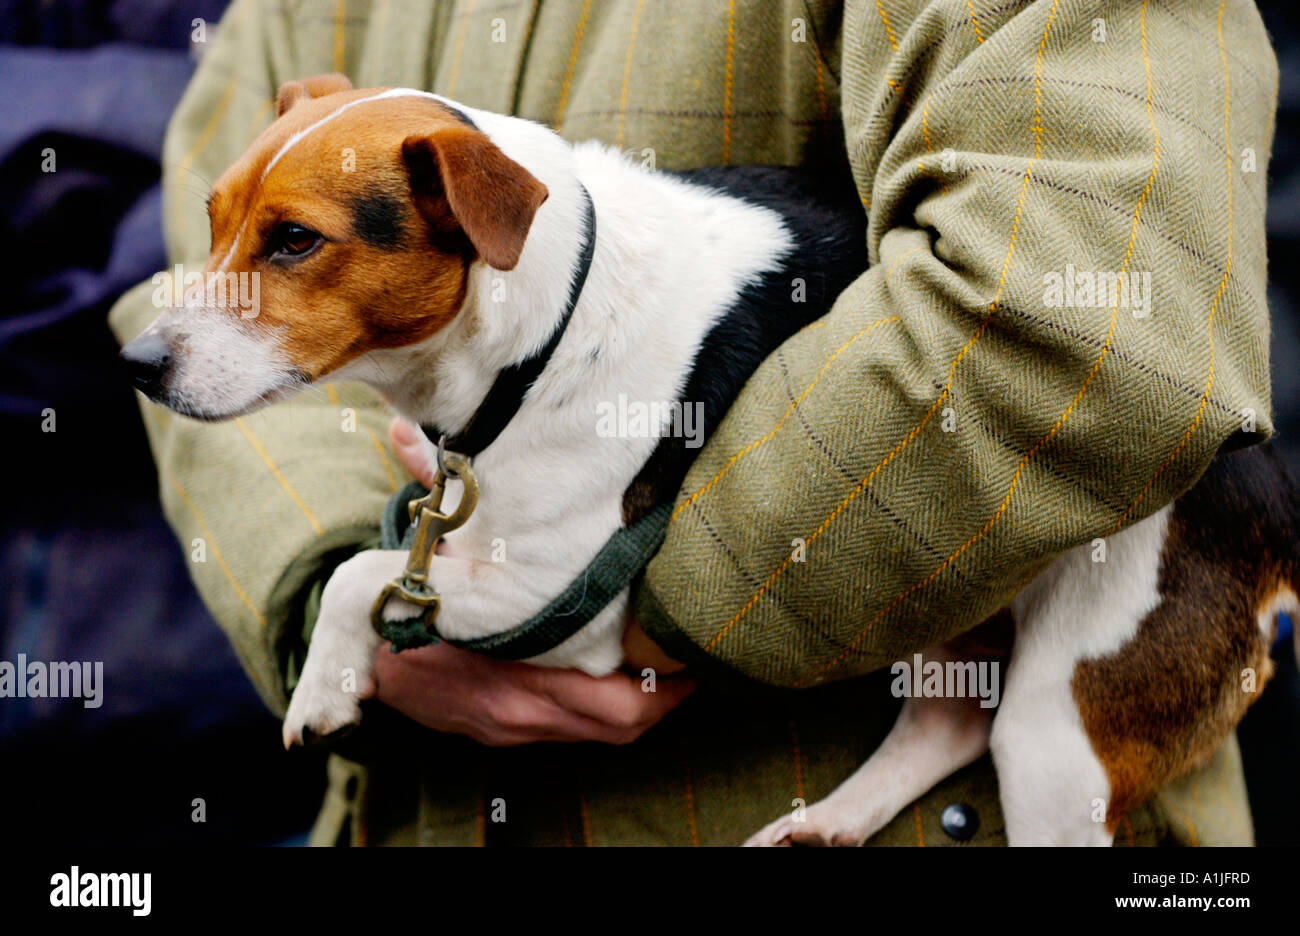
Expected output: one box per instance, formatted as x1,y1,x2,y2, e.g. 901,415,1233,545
402,126,550,270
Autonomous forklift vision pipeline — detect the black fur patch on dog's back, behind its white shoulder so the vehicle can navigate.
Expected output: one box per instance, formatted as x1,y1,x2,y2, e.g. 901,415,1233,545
623,166,867,524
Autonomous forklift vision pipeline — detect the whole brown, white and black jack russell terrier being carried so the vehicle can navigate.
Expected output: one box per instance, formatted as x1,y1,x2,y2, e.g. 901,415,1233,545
122,75,1300,845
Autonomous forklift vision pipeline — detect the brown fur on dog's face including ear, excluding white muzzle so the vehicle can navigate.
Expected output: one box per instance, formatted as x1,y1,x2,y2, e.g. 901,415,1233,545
197,77,546,380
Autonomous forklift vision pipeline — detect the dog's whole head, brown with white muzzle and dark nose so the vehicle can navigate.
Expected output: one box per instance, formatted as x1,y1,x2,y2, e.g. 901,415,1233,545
122,75,547,420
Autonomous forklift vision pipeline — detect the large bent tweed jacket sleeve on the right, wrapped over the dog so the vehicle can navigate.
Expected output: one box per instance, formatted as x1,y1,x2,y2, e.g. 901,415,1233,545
638,0,1278,686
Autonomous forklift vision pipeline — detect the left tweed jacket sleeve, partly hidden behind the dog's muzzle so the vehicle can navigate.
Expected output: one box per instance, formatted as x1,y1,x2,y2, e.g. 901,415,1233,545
109,0,406,714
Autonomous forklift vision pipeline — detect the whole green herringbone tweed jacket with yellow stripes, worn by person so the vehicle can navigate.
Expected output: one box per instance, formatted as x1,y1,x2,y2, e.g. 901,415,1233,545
112,0,1278,845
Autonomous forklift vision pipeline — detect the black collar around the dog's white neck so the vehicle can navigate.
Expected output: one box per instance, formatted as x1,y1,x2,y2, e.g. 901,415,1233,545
420,182,595,459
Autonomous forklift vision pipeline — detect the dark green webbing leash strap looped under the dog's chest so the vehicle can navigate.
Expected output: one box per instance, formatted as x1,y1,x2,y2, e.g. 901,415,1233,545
380,481,672,660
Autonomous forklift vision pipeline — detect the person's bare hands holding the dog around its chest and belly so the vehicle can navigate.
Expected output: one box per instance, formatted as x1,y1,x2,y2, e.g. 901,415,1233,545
374,419,694,746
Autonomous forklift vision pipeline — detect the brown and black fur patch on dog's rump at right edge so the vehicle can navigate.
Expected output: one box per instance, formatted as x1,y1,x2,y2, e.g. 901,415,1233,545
1071,446,1300,832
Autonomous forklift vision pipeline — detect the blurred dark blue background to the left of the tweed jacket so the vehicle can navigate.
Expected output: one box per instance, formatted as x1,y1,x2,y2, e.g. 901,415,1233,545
0,0,324,844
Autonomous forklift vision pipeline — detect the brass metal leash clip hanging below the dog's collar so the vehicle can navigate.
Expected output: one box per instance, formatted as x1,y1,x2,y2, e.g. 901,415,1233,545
371,438,478,637
